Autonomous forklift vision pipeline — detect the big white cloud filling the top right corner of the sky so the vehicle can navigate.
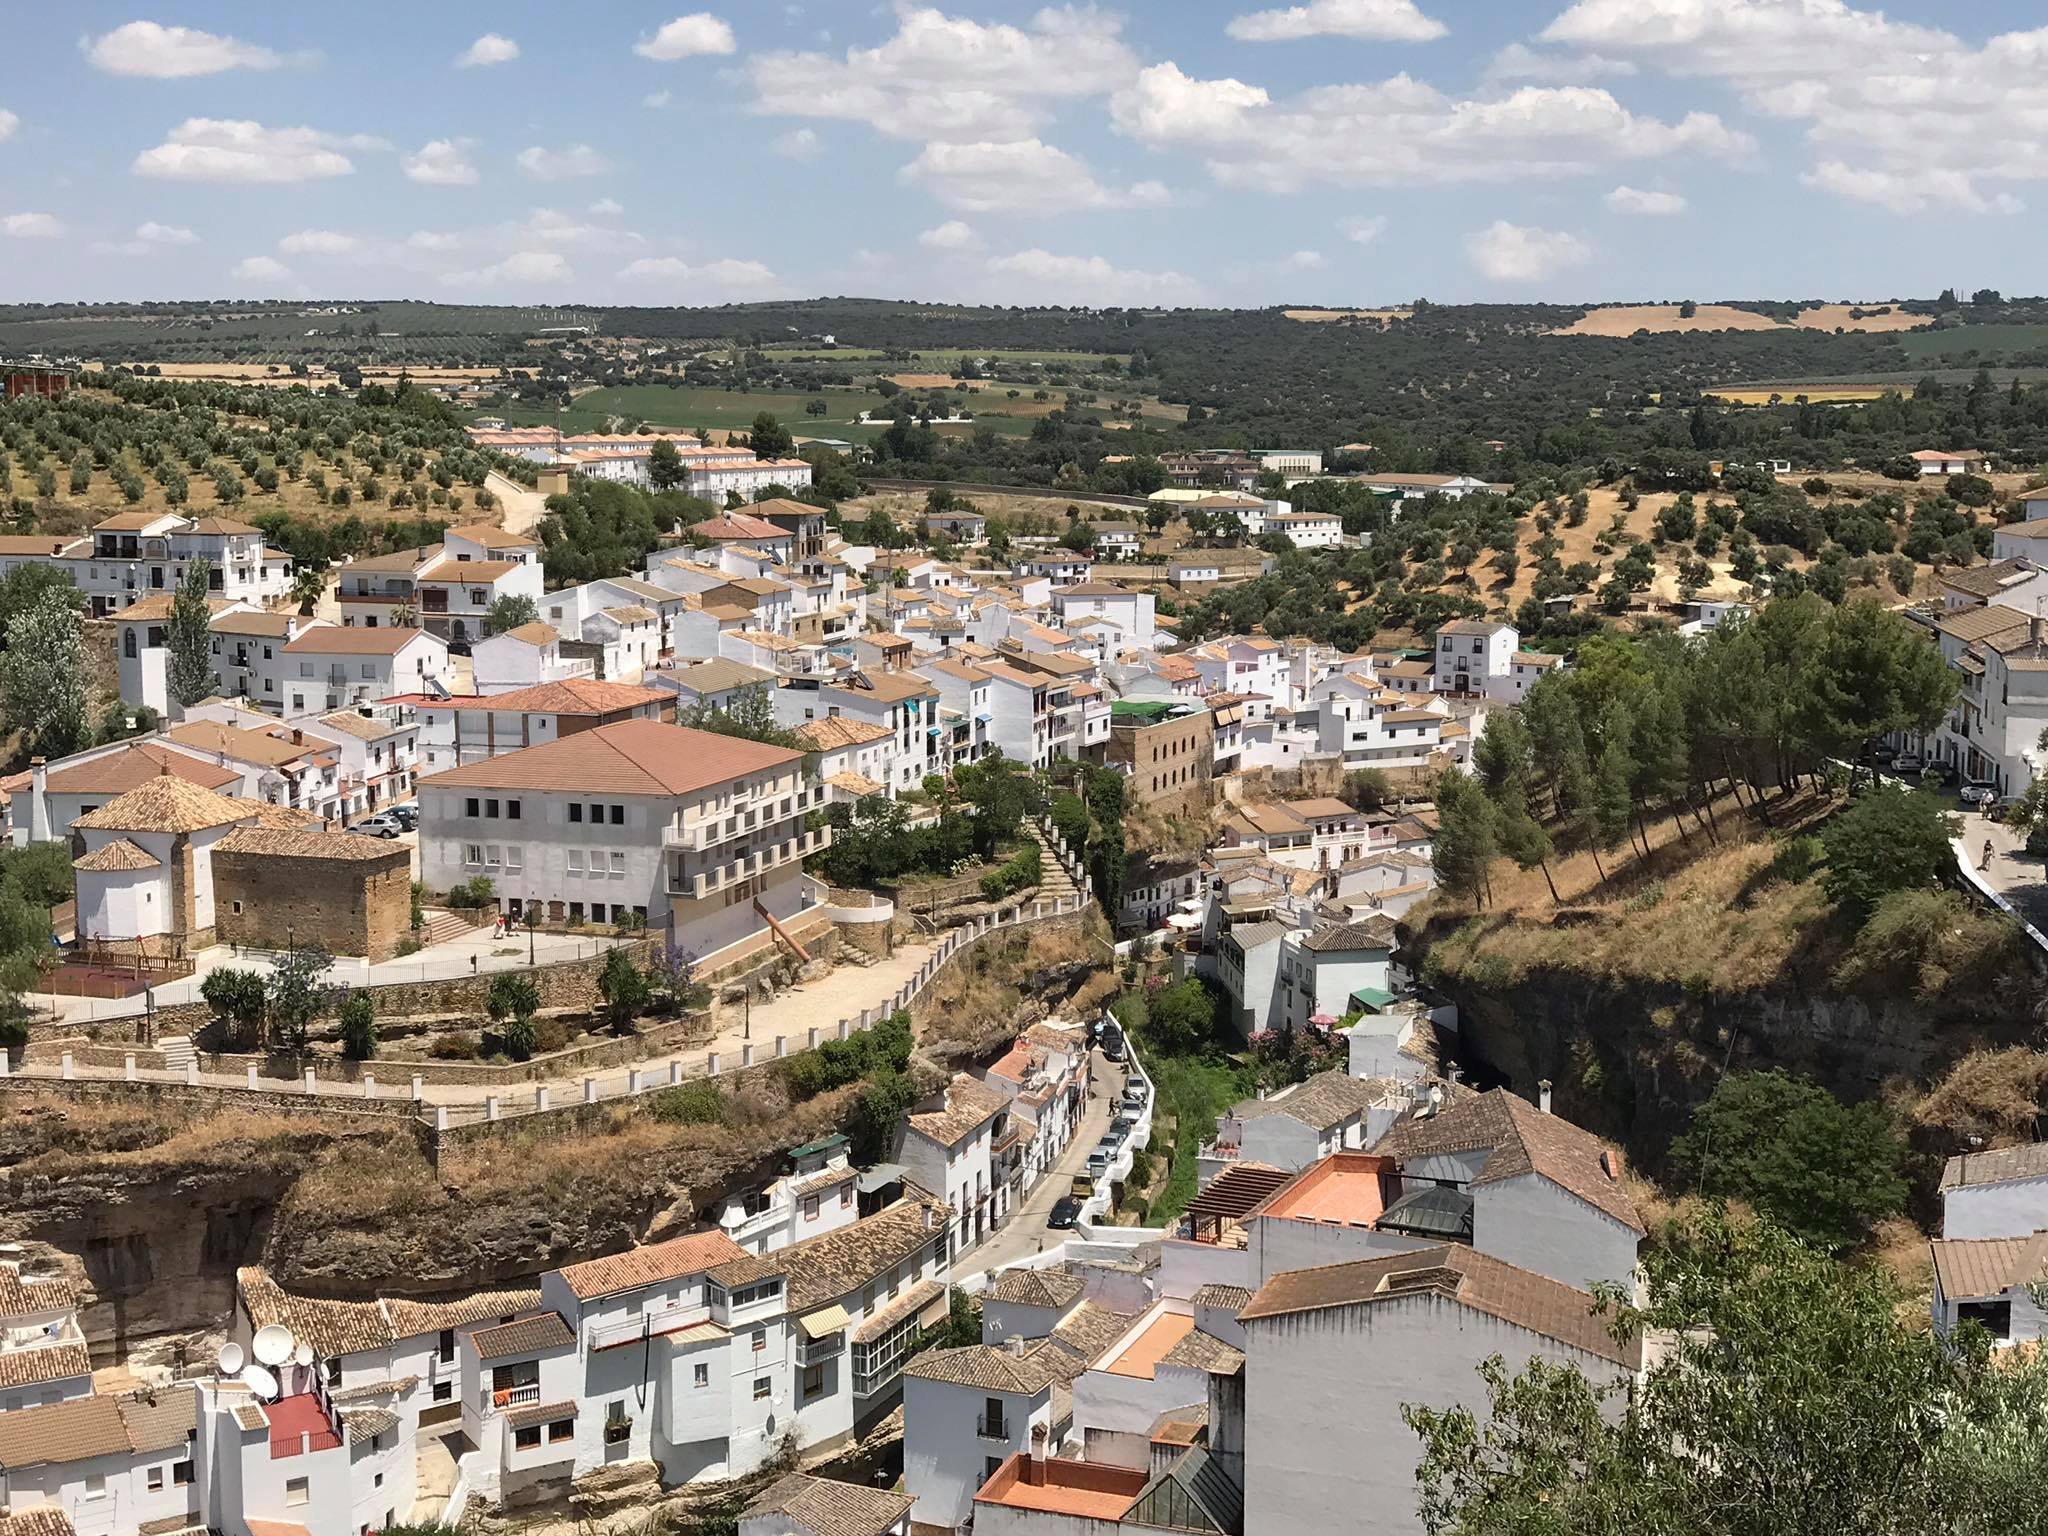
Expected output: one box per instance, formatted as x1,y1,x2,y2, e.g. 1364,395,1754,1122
1542,0,2048,213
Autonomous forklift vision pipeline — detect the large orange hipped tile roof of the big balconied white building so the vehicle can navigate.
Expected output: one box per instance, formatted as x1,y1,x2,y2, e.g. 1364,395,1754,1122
420,719,803,797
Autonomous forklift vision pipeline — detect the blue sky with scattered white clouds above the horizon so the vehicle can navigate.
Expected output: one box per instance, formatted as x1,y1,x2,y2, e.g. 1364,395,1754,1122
0,0,2048,305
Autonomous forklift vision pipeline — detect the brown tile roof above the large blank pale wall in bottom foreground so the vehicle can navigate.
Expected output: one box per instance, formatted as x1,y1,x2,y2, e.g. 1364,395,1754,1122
1237,1243,1642,1370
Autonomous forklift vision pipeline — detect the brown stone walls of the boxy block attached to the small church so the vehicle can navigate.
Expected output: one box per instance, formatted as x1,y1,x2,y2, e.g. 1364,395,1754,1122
213,846,412,961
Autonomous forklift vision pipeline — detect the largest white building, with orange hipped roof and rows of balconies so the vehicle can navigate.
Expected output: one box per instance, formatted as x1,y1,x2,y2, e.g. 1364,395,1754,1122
420,720,831,961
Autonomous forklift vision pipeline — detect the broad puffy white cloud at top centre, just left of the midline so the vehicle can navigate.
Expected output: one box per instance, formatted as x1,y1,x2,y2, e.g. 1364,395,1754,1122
745,6,1139,139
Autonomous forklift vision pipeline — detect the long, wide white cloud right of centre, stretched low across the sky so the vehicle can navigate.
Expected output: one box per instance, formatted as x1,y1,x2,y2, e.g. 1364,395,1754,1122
1110,63,1755,193
